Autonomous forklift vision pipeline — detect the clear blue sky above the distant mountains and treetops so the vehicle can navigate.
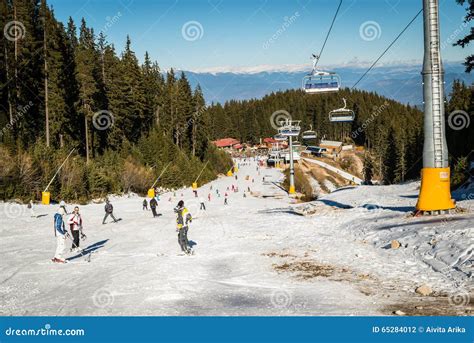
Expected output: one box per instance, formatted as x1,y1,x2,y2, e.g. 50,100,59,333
49,0,469,70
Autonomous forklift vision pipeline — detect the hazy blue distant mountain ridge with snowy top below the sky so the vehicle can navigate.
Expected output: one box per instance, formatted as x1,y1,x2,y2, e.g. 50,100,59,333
184,61,474,105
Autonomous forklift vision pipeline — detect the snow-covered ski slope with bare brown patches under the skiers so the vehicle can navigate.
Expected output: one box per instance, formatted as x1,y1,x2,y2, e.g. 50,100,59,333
0,162,474,315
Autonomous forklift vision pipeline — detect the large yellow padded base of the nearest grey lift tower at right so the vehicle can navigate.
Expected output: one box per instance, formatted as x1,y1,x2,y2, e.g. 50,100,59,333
416,168,456,211
